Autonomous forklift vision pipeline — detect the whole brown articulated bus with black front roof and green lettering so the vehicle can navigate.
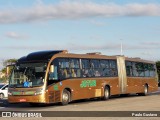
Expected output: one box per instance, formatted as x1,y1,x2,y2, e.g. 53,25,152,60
8,50,158,105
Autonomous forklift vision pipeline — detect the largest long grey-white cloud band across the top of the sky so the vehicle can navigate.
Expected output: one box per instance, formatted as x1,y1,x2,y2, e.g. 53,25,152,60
0,1,160,24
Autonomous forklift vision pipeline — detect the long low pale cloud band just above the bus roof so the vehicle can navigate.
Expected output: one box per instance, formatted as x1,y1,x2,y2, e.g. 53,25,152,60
4,43,160,51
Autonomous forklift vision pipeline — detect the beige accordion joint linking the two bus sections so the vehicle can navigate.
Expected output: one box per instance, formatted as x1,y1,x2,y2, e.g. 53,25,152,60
117,56,127,94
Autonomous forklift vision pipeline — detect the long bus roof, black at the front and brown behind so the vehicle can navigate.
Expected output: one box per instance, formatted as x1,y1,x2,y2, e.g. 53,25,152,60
18,50,154,63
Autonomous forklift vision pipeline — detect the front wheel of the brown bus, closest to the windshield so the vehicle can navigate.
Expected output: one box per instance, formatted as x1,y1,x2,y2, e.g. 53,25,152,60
61,89,71,105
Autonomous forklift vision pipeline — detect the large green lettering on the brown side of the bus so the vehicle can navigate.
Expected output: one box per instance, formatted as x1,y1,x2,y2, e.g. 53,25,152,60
80,80,96,88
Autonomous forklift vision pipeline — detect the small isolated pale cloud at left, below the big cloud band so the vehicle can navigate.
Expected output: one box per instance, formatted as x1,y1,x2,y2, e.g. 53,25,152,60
5,32,28,39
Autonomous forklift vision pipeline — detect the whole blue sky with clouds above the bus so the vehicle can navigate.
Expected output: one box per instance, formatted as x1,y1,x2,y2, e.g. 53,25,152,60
0,0,160,68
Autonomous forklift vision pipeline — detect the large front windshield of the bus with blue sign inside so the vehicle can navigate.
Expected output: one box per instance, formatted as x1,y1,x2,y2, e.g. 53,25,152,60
9,63,47,88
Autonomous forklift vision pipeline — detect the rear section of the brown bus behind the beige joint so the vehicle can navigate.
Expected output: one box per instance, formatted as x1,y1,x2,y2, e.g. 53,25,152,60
125,58,158,95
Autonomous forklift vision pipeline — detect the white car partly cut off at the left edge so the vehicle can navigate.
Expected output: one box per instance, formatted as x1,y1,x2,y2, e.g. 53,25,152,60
0,84,8,99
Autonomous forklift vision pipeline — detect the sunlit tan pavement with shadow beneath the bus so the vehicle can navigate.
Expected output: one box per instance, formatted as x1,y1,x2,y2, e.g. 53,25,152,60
0,88,160,120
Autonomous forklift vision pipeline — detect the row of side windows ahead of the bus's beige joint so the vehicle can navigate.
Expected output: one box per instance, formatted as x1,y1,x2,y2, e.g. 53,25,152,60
54,58,118,79
